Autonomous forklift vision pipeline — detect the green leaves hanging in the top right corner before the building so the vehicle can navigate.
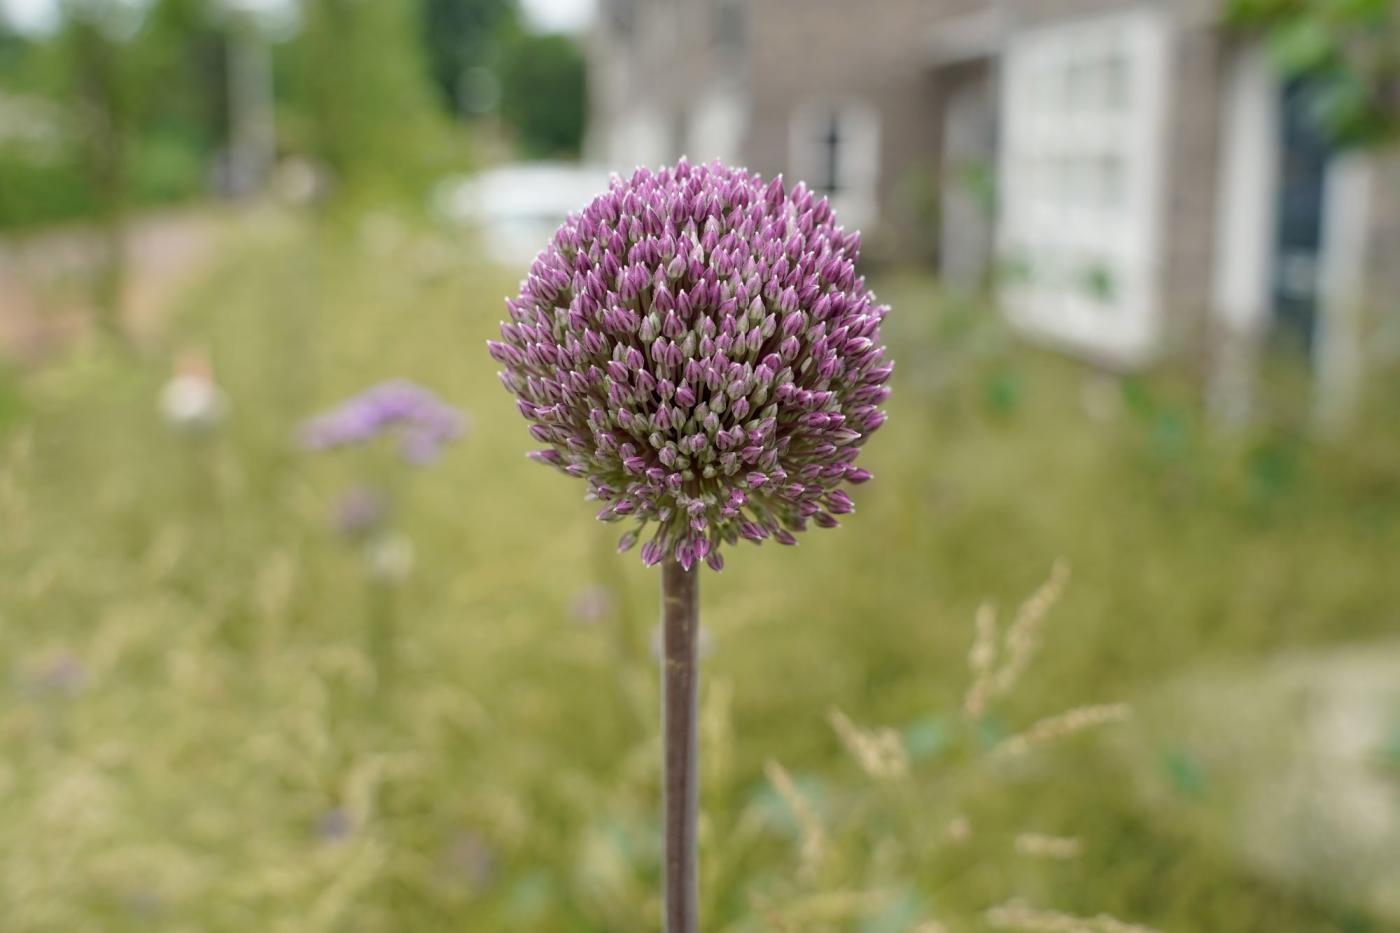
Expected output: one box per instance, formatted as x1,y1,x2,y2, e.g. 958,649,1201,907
1228,0,1400,146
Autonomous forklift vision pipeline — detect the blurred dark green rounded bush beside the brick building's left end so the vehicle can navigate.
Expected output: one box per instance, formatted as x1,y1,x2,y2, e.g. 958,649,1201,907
501,34,588,156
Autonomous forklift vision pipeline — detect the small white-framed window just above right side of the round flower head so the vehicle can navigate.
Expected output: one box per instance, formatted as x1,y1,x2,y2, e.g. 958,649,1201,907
788,98,879,230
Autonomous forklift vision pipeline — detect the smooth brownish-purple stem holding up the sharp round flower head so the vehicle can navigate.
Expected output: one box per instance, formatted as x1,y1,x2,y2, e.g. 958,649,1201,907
661,559,700,933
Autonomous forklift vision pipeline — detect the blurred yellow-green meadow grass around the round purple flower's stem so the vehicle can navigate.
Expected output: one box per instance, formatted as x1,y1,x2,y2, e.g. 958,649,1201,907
0,205,1400,933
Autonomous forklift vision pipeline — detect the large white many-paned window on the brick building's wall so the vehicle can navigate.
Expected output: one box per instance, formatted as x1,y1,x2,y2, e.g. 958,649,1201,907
997,7,1172,366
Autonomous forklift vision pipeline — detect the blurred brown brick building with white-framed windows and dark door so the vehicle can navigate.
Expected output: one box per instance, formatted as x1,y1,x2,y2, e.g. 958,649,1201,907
591,0,1400,406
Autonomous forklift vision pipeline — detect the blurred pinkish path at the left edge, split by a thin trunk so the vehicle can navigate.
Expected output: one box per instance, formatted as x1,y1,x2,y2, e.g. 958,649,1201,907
0,207,220,363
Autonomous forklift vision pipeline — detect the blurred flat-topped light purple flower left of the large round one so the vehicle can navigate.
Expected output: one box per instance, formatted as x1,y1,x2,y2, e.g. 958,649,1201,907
301,381,465,464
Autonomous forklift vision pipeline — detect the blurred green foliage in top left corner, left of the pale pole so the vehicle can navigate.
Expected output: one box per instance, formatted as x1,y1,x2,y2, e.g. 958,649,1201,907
0,0,227,227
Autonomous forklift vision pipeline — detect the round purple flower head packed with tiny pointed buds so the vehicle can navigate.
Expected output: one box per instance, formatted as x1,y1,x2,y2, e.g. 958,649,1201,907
487,161,893,570
